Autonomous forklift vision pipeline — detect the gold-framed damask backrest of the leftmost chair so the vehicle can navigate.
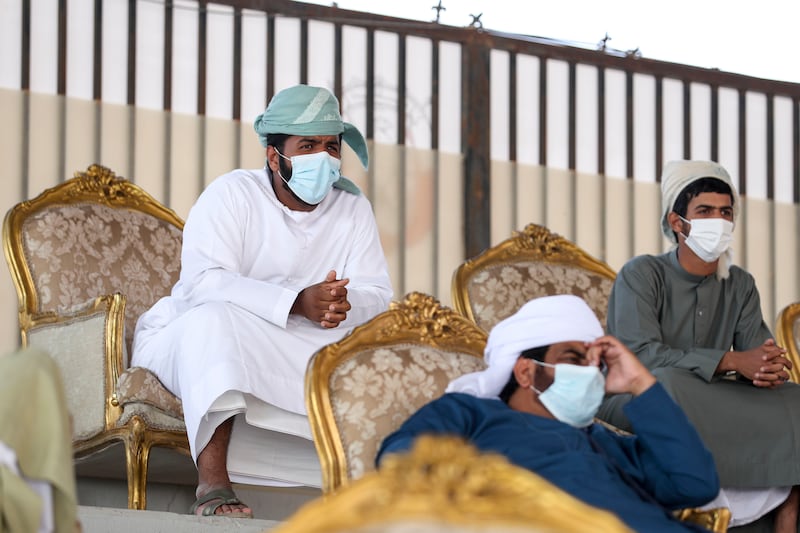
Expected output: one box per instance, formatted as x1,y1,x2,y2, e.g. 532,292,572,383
3,165,183,360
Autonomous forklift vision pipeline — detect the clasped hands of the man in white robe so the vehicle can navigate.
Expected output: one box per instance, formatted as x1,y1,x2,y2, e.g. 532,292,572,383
291,270,351,328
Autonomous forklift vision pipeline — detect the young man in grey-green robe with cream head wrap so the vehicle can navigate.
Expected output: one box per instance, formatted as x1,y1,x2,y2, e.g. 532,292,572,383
598,161,800,533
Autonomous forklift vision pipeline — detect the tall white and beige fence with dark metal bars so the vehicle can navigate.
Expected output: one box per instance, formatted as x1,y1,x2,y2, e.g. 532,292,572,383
0,0,800,354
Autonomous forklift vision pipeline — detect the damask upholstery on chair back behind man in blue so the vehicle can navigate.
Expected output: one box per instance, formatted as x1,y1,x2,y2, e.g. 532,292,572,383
330,344,485,479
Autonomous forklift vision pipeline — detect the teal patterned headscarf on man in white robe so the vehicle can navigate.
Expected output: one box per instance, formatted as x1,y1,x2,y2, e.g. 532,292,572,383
253,85,369,168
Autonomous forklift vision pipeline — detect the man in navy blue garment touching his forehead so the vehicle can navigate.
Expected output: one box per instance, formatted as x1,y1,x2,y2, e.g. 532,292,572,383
376,295,719,532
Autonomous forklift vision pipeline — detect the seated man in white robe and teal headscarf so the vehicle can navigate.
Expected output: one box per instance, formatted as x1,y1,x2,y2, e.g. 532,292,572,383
132,85,392,517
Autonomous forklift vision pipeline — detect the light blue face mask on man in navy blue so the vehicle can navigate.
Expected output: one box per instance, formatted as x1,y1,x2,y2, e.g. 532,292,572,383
531,360,606,428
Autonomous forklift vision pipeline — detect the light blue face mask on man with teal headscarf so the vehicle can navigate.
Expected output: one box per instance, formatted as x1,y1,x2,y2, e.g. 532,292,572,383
275,148,342,205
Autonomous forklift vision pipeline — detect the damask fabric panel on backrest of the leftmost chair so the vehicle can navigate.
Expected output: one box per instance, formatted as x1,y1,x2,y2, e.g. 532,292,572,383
22,203,182,353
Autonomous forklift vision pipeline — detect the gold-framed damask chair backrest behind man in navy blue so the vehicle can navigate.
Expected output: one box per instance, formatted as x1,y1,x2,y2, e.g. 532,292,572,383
306,293,486,492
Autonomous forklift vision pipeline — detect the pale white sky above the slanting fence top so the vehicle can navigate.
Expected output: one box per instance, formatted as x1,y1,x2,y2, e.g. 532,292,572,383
304,0,800,83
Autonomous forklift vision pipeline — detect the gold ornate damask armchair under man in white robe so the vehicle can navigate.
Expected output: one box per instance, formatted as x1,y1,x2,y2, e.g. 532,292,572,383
3,165,189,509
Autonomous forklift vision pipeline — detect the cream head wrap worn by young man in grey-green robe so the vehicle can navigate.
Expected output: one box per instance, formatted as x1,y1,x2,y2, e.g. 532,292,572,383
661,161,739,279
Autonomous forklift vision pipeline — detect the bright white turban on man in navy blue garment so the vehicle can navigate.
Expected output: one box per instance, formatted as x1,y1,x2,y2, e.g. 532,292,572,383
447,294,603,398
